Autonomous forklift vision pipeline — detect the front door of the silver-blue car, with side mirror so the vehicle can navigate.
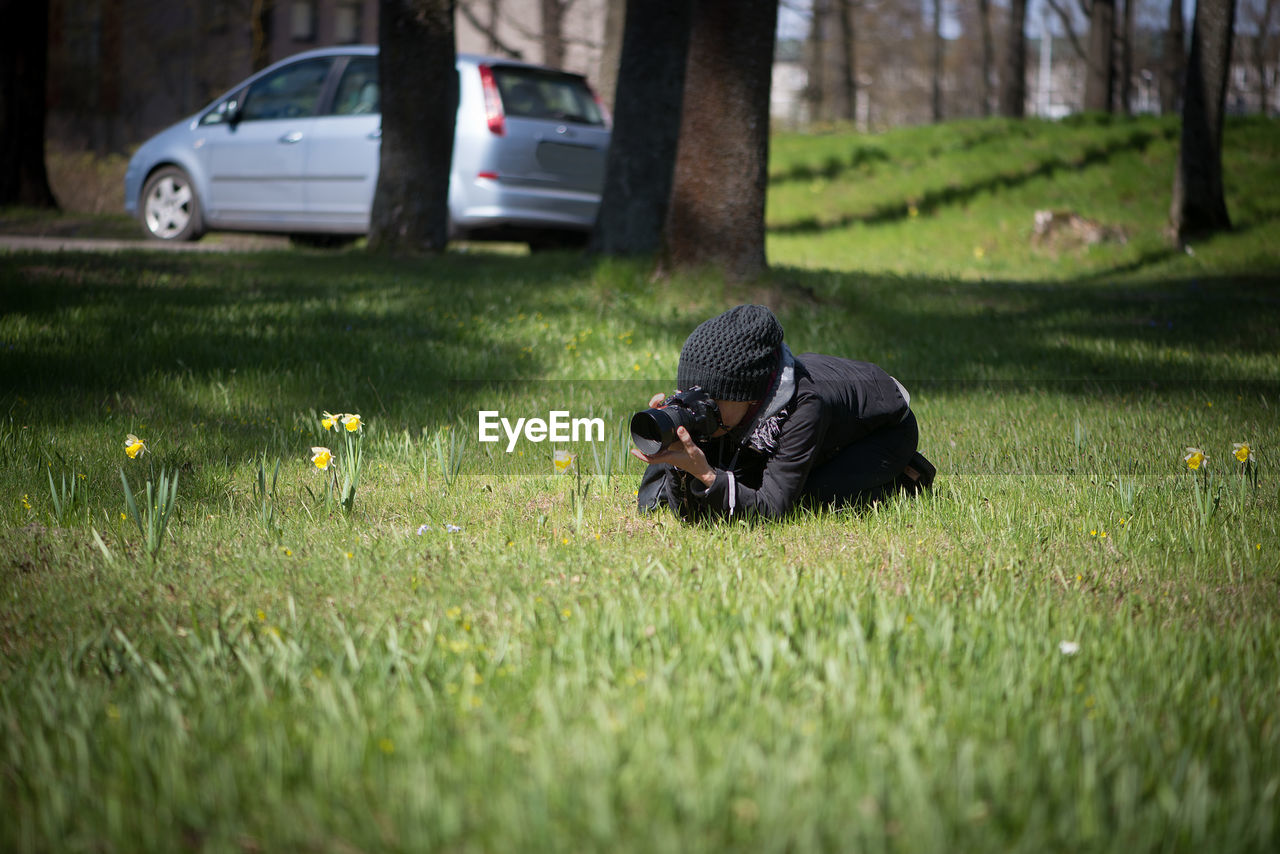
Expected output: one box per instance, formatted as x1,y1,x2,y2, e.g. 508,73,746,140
202,56,333,228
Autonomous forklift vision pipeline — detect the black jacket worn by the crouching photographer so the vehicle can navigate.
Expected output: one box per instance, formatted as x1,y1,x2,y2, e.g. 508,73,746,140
639,353,909,520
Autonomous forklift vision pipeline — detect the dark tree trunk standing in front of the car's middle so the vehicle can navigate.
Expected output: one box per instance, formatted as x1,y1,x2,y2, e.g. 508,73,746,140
369,0,458,254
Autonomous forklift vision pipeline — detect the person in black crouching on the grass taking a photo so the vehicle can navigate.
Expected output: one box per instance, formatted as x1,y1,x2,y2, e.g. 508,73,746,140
631,306,936,520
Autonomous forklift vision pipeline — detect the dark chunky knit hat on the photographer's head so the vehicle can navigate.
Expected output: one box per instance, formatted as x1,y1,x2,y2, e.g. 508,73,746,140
676,306,782,401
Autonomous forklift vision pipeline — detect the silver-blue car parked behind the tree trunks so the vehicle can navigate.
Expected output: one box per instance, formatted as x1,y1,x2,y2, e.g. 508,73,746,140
124,45,609,248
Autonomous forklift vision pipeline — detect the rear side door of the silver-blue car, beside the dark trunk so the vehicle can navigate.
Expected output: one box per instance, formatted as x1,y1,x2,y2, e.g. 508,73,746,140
305,56,383,232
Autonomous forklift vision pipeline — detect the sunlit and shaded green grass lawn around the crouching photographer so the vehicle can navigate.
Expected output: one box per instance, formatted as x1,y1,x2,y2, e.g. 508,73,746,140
0,115,1280,851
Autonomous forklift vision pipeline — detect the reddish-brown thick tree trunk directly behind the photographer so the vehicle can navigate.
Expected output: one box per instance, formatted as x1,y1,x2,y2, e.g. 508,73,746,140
666,0,778,280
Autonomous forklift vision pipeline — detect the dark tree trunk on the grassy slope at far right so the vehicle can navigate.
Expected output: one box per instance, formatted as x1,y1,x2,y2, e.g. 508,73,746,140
1169,0,1235,245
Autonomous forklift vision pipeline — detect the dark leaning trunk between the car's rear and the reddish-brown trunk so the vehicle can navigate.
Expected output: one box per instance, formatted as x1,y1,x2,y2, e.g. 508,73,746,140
591,0,692,255
